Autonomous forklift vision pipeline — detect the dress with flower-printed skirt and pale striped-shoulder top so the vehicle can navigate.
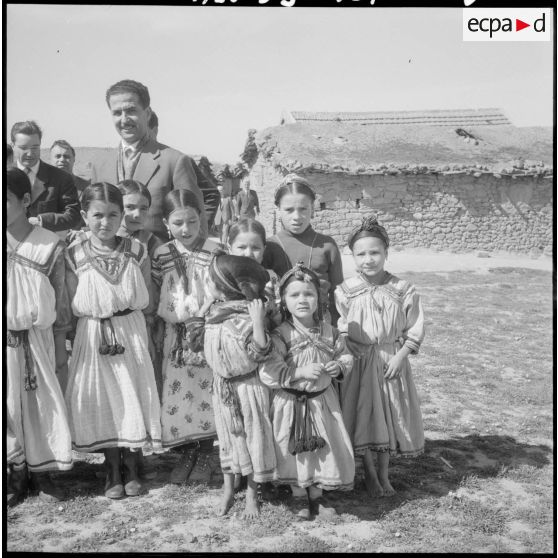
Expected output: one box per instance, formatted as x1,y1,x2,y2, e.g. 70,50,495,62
153,240,219,447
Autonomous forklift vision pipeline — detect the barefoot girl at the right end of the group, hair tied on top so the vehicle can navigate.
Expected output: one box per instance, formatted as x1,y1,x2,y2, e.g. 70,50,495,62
335,217,425,497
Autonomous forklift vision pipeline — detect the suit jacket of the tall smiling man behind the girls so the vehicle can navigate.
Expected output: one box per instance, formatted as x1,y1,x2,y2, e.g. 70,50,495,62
91,140,220,240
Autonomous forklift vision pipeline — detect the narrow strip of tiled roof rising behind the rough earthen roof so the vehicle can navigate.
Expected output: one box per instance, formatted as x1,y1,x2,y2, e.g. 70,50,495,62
285,108,511,126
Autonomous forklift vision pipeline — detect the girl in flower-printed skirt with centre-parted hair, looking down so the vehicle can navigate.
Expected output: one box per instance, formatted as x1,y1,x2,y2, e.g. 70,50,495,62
153,189,223,484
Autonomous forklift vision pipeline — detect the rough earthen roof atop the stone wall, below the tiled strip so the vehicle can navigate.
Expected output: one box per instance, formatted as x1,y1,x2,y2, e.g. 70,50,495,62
256,122,553,176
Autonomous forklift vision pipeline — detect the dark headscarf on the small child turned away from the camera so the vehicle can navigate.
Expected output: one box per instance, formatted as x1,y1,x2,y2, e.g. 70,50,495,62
209,253,269,300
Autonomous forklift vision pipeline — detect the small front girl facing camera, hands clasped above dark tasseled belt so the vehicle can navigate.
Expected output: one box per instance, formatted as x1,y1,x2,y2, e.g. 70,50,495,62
260,263,355,519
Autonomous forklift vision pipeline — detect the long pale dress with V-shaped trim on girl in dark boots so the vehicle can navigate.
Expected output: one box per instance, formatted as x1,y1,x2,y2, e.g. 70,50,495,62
66,237,161,452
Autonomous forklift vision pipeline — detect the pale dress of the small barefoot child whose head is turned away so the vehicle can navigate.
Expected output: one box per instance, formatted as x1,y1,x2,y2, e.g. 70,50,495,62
187,300,276,482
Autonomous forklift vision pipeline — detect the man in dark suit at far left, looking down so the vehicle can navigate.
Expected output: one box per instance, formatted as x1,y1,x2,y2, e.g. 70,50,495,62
10,120,80,235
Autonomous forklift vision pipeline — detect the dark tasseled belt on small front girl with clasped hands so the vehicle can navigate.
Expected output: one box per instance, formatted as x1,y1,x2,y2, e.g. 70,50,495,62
282,386,329,455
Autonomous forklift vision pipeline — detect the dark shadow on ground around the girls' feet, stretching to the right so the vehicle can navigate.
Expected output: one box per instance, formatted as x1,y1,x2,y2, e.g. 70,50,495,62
52,434,552,521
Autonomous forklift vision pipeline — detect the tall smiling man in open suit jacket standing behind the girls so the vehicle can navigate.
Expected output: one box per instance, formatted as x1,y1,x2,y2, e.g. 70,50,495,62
92,80,219,240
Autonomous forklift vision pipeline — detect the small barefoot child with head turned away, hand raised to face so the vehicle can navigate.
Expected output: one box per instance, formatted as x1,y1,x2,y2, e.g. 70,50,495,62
187,254,276,518
